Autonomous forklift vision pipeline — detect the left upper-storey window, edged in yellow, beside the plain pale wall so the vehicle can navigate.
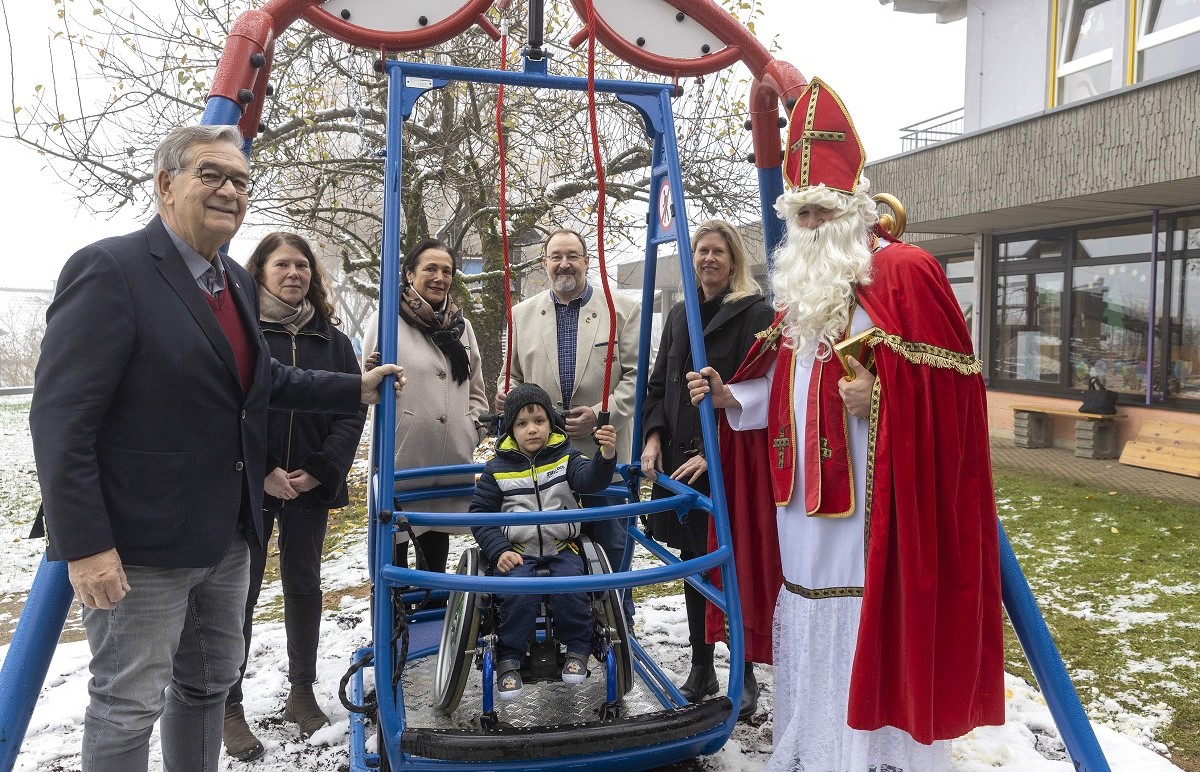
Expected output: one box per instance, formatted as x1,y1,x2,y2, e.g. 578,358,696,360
1057,0,1118,104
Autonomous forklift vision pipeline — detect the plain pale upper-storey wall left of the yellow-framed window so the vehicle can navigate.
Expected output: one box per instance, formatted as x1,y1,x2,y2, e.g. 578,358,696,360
962,0,1050,132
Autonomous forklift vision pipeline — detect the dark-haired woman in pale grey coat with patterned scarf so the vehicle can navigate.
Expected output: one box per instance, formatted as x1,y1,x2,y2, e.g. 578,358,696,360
362,238,487,571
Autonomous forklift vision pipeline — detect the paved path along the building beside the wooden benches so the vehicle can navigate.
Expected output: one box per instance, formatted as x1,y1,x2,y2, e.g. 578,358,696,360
991,437,1200,507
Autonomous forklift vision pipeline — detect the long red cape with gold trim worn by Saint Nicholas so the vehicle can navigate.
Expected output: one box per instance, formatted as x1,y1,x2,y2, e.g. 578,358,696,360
708,244,1004,743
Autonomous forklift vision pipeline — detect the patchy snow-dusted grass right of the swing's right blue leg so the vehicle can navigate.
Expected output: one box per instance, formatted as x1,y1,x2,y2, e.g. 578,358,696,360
996,473,1200,770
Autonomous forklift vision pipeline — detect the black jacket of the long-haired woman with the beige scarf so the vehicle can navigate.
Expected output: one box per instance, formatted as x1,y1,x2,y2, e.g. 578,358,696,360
258,316,367,509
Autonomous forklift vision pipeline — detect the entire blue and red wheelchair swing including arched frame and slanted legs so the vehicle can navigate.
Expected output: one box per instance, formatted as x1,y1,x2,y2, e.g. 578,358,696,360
0,0,1109,772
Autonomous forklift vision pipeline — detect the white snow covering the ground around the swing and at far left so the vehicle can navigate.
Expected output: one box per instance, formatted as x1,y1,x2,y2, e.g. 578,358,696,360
0,397,1182,772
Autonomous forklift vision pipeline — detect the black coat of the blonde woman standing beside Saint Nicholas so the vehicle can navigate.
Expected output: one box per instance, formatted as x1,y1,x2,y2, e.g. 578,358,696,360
642,290,775,553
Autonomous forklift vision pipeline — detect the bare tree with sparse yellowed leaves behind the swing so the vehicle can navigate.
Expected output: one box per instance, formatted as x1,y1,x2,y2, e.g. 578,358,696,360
0,0,761,381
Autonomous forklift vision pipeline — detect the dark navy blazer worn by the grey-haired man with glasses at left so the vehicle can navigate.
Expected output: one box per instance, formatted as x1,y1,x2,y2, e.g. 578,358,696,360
29,217,360,568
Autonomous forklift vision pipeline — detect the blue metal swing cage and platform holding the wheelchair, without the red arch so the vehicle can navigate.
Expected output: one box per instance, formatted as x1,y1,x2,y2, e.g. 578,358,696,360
340,24,743,770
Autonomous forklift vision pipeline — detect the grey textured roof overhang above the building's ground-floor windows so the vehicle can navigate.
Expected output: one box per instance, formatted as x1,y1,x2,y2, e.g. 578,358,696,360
863,68,1200,249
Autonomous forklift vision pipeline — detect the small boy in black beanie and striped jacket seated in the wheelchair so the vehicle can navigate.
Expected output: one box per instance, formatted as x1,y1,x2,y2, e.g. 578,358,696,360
470,383,617,701
